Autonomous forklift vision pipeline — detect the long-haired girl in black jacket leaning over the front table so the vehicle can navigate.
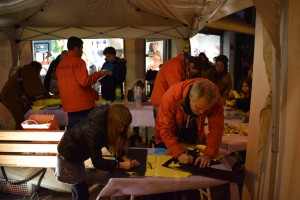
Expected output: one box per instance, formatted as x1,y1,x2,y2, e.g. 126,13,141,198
55,104,140,200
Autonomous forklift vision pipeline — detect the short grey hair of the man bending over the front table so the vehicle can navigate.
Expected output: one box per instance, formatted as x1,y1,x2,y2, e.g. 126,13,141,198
190,81,219,105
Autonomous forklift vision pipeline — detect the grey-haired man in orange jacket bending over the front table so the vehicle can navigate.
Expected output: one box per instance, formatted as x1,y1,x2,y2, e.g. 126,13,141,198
155,78,224,167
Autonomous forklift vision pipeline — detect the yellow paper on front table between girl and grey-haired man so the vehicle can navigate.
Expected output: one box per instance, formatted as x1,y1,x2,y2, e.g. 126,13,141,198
145,155,192,178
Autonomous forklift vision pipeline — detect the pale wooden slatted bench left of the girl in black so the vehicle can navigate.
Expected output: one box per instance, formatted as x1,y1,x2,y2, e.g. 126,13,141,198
0,130,93,168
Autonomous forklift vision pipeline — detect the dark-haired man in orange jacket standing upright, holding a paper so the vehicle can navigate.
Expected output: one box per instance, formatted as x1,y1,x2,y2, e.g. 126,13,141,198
56,36,112,127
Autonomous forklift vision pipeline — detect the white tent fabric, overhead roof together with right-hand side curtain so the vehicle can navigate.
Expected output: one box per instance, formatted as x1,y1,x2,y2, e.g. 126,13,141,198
7,0,300,199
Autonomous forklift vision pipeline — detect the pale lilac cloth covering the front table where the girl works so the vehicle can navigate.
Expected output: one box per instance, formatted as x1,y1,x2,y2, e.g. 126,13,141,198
97,148,239,199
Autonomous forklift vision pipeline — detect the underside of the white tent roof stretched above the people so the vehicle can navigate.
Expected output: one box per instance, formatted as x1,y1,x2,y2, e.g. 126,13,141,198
0,0,253,41
